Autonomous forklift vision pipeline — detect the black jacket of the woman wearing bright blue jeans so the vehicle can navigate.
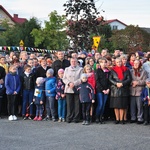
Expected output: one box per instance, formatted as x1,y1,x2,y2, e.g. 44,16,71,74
96,68,110,93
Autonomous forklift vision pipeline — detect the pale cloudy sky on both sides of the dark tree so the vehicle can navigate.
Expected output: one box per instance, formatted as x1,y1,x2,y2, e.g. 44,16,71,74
0,0,150,28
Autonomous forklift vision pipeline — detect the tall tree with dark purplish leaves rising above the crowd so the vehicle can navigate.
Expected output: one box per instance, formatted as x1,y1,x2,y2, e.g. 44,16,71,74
64,0,103,50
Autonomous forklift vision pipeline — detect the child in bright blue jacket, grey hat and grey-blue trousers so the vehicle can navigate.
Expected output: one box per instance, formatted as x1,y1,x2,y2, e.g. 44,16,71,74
44,69,56,122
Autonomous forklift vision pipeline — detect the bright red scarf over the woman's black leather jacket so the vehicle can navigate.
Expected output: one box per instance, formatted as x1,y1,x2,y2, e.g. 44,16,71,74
112,66,127,80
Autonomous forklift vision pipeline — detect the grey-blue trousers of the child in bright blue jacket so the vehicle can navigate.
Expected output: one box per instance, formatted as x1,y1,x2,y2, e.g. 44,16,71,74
46,96,56,118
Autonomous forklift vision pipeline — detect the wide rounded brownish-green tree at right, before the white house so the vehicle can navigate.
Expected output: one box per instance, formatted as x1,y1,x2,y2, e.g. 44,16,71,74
111,25,150,53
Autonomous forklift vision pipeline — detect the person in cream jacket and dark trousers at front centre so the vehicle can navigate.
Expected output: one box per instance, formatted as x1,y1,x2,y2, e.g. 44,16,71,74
63,58,83,123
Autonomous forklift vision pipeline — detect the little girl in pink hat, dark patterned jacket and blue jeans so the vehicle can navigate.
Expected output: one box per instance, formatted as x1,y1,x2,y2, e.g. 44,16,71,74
56,69,66,122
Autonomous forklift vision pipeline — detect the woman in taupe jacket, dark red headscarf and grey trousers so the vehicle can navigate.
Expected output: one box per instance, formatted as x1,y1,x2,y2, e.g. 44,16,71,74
130,60,147,124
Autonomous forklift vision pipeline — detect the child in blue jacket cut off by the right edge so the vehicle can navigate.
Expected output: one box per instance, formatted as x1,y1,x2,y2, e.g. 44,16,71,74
141,78,150,125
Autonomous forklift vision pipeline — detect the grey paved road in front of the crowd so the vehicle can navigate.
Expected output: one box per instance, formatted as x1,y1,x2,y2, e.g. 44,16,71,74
0,118,150,150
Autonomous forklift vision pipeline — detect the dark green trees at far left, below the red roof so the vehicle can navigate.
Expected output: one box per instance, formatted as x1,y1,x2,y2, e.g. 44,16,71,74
0,18,41,47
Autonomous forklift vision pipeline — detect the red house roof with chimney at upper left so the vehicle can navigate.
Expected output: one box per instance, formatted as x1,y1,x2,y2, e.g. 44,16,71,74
0,5,27,24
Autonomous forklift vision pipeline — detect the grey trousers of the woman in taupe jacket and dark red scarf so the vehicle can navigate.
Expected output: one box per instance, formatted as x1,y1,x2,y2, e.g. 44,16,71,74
130,96,143,121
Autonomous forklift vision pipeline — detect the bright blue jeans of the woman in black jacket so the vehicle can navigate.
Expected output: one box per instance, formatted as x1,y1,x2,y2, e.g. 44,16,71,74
96,93,108,117
